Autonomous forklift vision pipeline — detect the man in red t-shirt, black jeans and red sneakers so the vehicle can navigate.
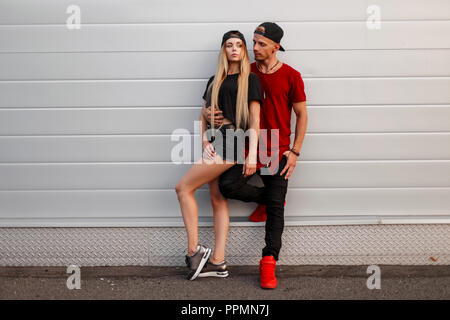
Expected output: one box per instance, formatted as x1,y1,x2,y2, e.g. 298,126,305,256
204,22,308,289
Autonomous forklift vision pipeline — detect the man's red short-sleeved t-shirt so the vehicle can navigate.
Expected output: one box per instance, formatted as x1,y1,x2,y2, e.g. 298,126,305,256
245,62,306,174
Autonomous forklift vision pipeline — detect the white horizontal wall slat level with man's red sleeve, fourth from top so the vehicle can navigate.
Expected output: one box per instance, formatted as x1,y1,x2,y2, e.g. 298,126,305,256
0,77,450,108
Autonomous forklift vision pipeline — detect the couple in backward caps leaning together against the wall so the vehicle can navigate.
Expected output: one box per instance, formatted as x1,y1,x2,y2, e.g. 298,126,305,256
175,22,307,289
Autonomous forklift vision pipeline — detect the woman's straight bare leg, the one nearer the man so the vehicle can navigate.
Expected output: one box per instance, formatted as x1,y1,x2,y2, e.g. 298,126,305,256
209,178,230,264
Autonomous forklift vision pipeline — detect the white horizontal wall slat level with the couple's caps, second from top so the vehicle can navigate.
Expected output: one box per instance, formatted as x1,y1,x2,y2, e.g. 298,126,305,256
0,20,450,52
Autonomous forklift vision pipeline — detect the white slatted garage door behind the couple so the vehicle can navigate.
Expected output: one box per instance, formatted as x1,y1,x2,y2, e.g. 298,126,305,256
0,0,450,227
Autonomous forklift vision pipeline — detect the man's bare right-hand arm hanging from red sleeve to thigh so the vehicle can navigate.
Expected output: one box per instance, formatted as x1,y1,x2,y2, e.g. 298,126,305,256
280,101,308,179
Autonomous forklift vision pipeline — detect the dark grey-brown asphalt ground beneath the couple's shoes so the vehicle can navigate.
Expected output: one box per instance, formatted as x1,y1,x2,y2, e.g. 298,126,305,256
0,265,450,300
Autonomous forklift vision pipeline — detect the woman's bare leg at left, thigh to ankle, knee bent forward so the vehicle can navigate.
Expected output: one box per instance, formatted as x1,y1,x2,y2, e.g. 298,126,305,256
175,155,234,254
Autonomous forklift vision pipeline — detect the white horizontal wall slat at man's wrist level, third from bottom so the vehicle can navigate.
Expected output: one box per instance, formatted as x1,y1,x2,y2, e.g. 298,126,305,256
0,132,450,162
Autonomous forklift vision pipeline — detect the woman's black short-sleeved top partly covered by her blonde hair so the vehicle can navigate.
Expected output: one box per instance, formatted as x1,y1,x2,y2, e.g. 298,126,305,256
203,72,262,126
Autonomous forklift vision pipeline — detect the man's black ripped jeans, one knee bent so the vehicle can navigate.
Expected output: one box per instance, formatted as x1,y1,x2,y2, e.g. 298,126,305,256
219,155,289,260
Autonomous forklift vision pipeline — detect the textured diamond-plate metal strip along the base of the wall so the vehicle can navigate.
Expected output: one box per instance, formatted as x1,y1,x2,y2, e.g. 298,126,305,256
0,224,450,266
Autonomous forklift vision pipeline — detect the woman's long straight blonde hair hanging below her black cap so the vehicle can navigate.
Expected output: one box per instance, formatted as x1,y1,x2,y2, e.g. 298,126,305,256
208,34,250,130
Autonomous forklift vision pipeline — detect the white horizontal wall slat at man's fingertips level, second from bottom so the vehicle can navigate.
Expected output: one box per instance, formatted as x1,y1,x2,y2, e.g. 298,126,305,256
0,160,450,192
